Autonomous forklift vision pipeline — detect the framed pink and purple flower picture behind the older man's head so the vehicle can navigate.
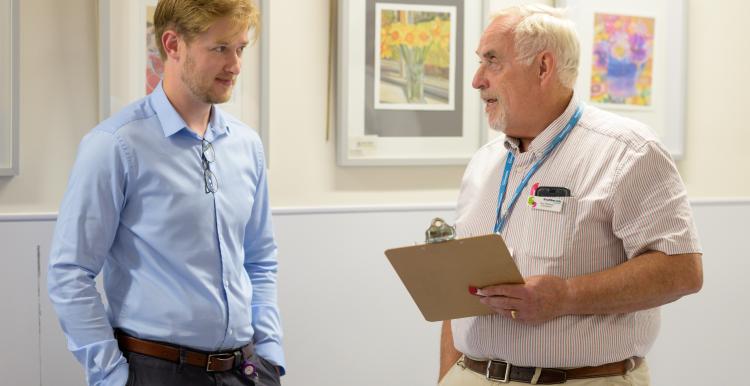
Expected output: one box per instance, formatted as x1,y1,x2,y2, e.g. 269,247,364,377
556,0,686,158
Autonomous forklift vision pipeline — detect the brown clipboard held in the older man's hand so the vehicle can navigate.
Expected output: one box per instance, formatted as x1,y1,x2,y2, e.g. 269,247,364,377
385,234,524,322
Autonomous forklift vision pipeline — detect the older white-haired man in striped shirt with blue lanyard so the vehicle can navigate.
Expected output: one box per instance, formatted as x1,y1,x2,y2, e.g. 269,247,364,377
440,5,703,386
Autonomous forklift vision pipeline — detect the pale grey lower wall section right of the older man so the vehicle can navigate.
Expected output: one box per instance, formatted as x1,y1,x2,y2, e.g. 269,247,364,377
648,203,750,386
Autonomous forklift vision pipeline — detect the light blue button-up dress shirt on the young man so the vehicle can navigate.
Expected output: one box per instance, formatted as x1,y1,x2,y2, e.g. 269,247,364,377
48,85,284,386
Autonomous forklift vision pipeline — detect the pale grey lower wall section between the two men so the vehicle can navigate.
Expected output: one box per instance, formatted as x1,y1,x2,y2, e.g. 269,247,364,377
274,208,453,386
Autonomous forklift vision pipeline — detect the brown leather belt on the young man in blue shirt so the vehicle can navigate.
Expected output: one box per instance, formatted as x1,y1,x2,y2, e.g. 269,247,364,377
115,331,253,372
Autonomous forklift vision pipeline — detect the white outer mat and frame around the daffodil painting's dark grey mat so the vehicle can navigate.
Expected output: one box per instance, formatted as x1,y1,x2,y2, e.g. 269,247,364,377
338,0,486,166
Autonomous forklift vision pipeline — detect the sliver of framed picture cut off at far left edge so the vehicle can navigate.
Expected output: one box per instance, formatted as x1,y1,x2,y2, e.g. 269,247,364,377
0,0,18,176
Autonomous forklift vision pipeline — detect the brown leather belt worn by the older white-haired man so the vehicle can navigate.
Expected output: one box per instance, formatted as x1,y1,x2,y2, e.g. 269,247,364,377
459,356,643,385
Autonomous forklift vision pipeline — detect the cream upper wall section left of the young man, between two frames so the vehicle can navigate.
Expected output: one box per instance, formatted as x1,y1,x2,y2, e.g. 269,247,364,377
0,0,98,213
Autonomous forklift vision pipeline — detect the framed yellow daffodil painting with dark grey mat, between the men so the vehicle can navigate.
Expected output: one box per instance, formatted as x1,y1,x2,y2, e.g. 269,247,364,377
336,0,486,166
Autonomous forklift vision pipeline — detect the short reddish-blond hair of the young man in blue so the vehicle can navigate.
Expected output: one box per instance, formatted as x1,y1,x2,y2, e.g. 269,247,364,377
154,0,260,60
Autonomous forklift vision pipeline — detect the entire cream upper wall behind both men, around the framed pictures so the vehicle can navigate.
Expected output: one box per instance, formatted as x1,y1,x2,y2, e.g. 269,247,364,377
0,0,750,213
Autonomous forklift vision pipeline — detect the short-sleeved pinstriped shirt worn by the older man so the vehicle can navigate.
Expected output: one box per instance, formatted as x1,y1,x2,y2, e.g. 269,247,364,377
452,97,700,367
